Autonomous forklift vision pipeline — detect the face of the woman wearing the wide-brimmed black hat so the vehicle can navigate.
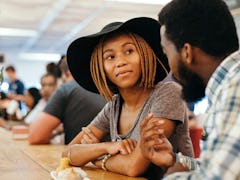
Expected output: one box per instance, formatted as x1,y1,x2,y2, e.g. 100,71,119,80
103,34,141,90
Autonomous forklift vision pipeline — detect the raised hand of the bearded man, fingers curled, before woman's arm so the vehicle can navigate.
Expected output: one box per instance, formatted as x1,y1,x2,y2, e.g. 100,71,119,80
140,114,175,168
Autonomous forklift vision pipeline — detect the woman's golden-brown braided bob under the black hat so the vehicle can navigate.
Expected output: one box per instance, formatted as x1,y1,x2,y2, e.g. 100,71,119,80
90,32,167,100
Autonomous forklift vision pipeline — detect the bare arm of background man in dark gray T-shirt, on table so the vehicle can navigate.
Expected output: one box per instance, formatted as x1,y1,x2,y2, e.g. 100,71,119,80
28,112,61,144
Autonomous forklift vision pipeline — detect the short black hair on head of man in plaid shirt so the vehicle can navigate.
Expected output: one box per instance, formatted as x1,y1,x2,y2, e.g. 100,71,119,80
158,0,239,58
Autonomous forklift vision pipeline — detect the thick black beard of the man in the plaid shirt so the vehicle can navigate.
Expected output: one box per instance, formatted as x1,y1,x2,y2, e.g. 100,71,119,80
178,60,205,102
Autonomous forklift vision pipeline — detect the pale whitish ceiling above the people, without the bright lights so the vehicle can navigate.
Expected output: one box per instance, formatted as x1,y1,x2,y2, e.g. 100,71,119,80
0,0,240,62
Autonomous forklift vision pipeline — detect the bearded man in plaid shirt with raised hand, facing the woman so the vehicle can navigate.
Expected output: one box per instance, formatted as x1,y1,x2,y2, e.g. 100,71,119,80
141,0,240,179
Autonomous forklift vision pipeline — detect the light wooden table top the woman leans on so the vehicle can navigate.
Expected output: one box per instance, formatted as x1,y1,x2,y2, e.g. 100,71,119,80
0,128,144,180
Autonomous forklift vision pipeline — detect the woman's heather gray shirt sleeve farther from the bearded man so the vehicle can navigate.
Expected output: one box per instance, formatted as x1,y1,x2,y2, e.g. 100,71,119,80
91,102,111,133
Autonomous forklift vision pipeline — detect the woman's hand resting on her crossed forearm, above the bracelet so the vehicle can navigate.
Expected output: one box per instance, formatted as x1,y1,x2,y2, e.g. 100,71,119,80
107,139,137,155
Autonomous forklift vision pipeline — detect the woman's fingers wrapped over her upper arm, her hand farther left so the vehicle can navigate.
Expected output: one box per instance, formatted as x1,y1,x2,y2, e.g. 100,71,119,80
81,127,100,144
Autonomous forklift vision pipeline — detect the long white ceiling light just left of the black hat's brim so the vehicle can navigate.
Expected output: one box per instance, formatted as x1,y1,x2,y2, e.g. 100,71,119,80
19,53,61,62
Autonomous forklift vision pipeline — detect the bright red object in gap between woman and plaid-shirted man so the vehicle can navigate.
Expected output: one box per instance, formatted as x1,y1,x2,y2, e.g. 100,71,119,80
189,127,203,158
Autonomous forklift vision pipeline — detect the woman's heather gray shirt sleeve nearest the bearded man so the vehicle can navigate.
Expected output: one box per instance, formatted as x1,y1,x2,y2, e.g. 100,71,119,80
151,82,186,122
